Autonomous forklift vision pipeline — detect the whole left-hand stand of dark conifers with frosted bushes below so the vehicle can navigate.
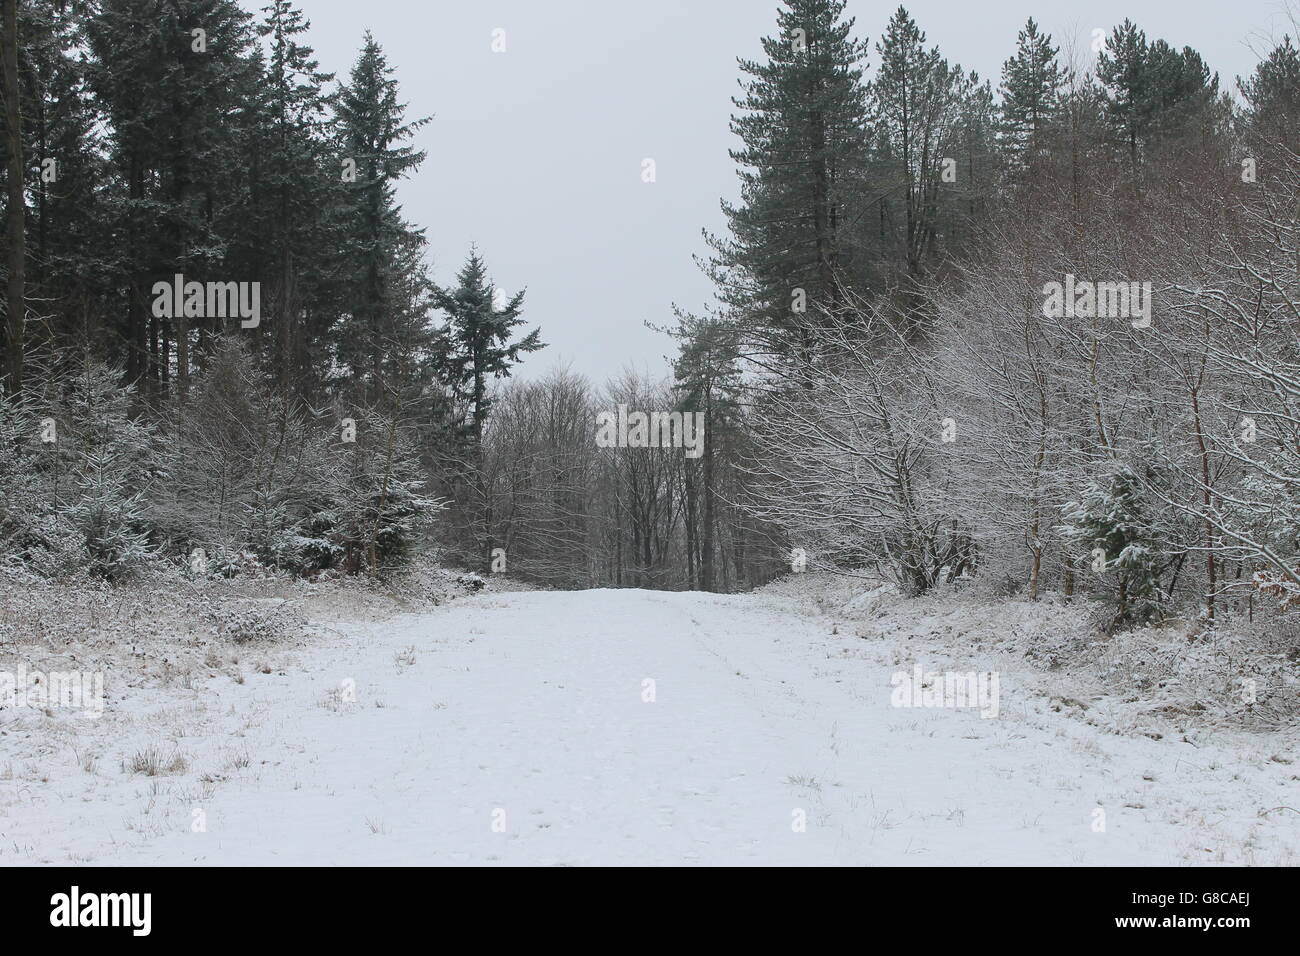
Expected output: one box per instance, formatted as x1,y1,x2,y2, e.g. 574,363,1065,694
0,0,542,576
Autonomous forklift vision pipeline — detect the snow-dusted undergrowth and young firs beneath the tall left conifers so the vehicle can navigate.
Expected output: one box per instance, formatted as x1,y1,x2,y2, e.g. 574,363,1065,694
0,343,441,580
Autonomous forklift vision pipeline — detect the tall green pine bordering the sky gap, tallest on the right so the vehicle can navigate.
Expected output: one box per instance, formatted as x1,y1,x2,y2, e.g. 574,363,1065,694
707,0,867,354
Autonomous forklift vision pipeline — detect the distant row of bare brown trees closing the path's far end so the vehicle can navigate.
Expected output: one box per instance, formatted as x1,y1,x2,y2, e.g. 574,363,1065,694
484,371,774,591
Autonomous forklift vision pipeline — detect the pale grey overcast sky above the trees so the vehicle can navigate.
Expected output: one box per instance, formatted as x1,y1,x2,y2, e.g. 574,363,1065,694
256,0,1290,384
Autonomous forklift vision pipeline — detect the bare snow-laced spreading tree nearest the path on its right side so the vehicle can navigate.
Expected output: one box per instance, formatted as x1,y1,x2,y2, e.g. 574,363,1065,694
748,304,971,594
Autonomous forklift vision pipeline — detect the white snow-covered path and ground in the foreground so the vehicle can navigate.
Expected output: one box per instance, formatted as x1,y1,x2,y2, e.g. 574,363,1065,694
0,591,1300,865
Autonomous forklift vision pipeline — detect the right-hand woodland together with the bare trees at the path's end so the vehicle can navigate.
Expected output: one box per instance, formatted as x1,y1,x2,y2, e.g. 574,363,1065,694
473,0,1300,628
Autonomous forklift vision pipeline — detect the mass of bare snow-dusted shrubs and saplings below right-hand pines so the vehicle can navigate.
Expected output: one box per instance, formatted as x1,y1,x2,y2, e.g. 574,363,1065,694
749,134,1300,632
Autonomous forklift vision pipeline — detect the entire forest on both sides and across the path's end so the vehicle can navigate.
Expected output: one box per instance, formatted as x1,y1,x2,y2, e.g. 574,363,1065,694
0,0,1300,642
